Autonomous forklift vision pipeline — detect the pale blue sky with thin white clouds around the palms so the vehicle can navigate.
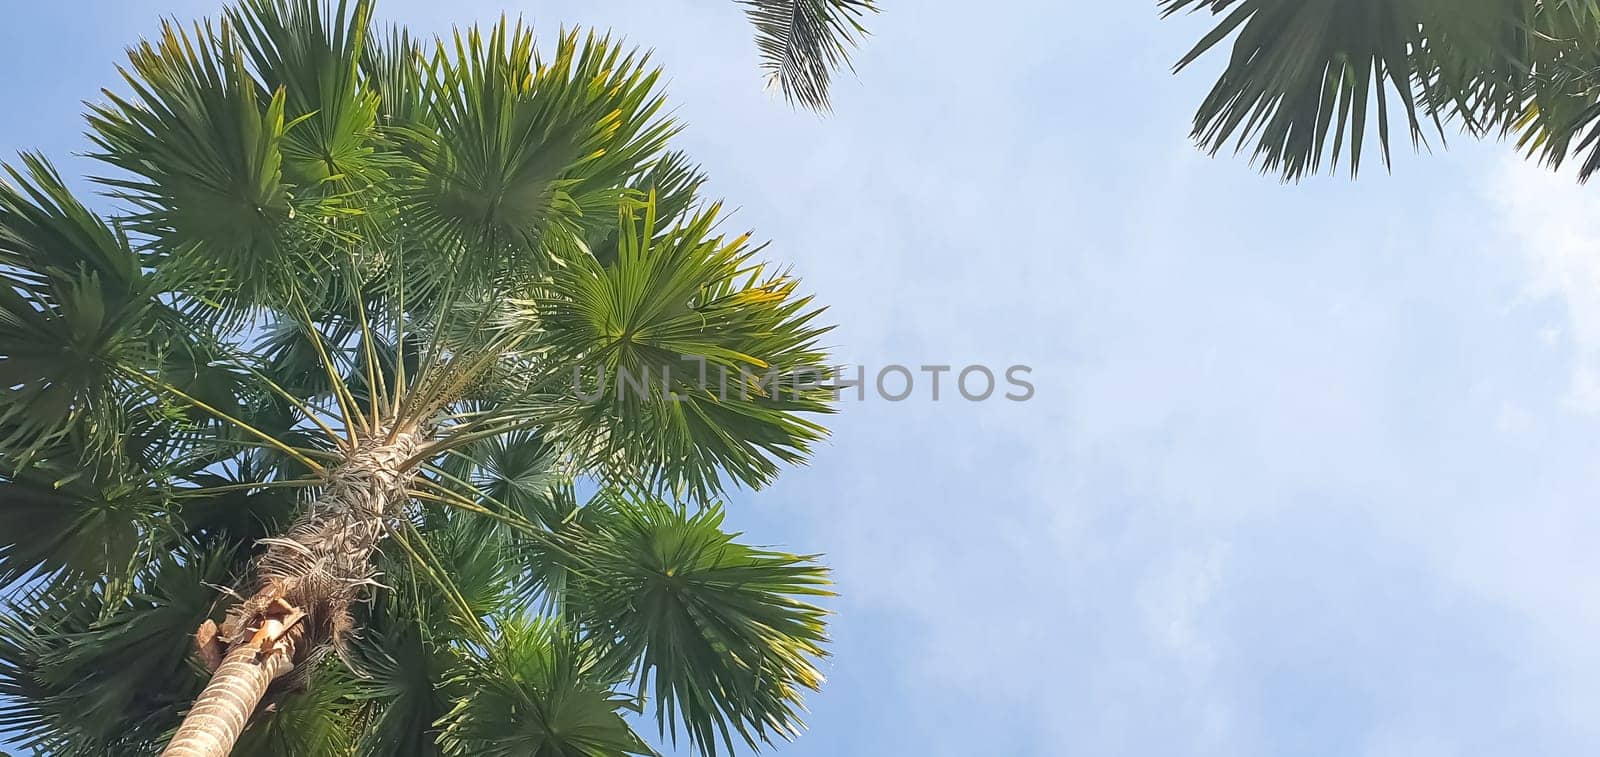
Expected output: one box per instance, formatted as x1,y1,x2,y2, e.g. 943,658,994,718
0,0,1600,757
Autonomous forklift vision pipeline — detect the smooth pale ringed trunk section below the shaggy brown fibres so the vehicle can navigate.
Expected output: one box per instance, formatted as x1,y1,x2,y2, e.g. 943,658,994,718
162,630,294,757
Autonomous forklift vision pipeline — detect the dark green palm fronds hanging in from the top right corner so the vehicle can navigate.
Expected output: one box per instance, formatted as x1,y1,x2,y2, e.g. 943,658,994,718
1162,0,1600,181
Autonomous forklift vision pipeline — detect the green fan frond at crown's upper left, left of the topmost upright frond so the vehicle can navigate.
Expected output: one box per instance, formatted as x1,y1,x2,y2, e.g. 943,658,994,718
90,15,293,304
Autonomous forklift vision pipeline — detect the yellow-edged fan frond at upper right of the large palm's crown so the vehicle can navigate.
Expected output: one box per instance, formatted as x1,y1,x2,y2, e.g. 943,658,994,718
403,19,675,280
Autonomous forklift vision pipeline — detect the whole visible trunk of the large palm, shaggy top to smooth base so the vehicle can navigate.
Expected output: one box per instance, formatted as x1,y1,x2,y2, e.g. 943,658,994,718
163,432,421,757
